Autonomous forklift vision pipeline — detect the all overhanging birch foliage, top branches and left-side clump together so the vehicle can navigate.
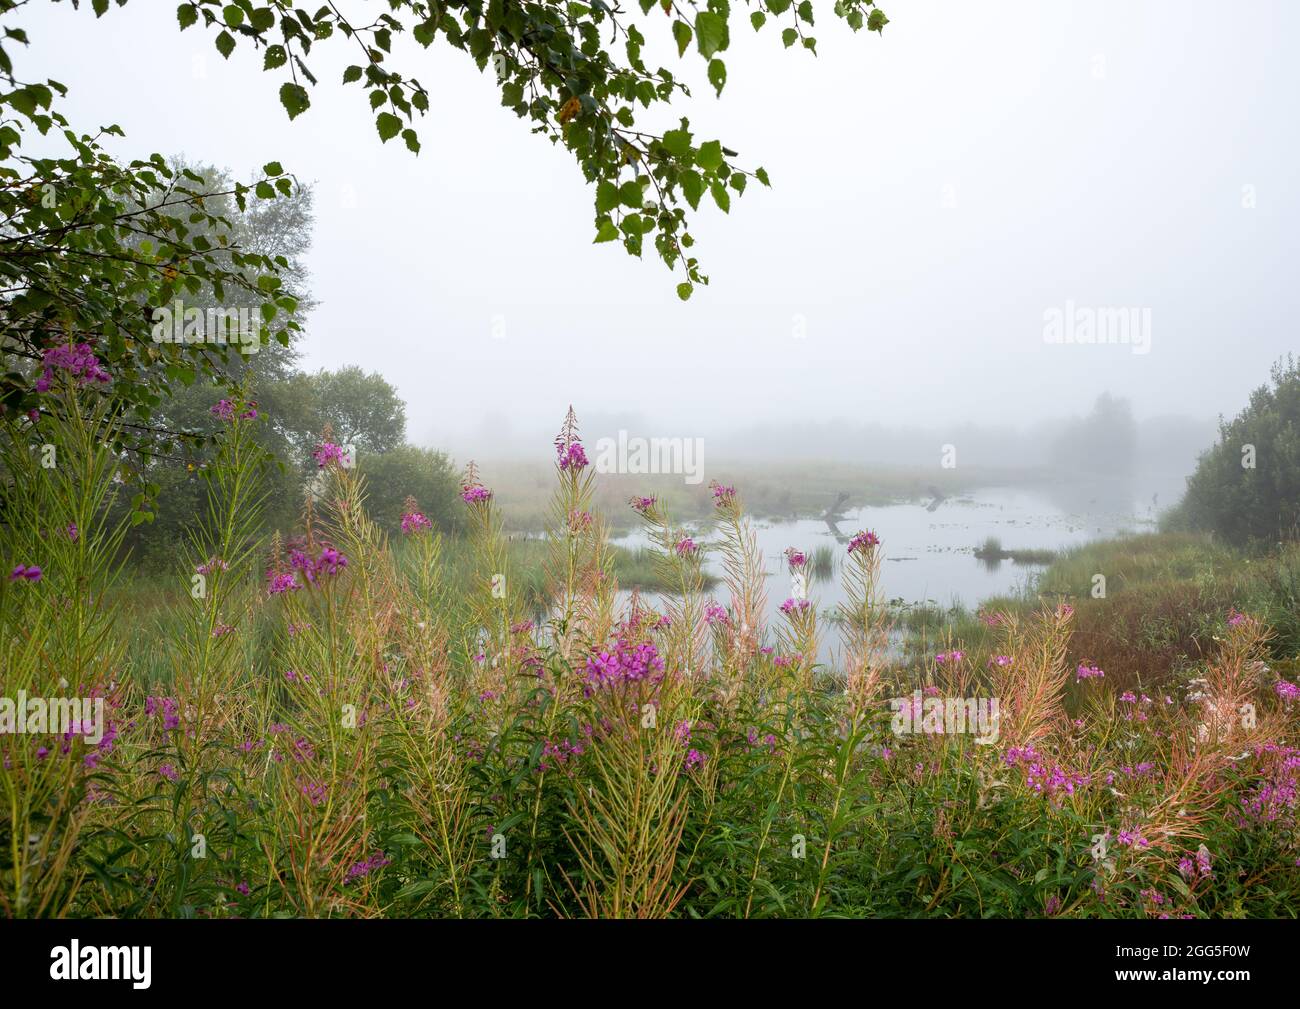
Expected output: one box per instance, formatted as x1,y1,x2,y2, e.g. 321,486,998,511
0,0,888,497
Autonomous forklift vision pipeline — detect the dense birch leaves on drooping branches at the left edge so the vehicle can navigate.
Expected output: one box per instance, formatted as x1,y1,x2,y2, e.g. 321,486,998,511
0,42,299,460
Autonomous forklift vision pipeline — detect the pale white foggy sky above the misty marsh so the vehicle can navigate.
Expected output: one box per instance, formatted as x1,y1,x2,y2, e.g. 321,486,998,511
13,0,1300,443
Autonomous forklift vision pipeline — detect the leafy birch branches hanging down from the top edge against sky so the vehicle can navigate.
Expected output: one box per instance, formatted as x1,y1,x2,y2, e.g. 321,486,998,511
154,0,888,291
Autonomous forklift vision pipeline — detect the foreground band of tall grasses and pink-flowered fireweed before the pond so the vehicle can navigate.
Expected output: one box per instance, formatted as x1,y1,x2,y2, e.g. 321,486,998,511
0,387,1300,918
